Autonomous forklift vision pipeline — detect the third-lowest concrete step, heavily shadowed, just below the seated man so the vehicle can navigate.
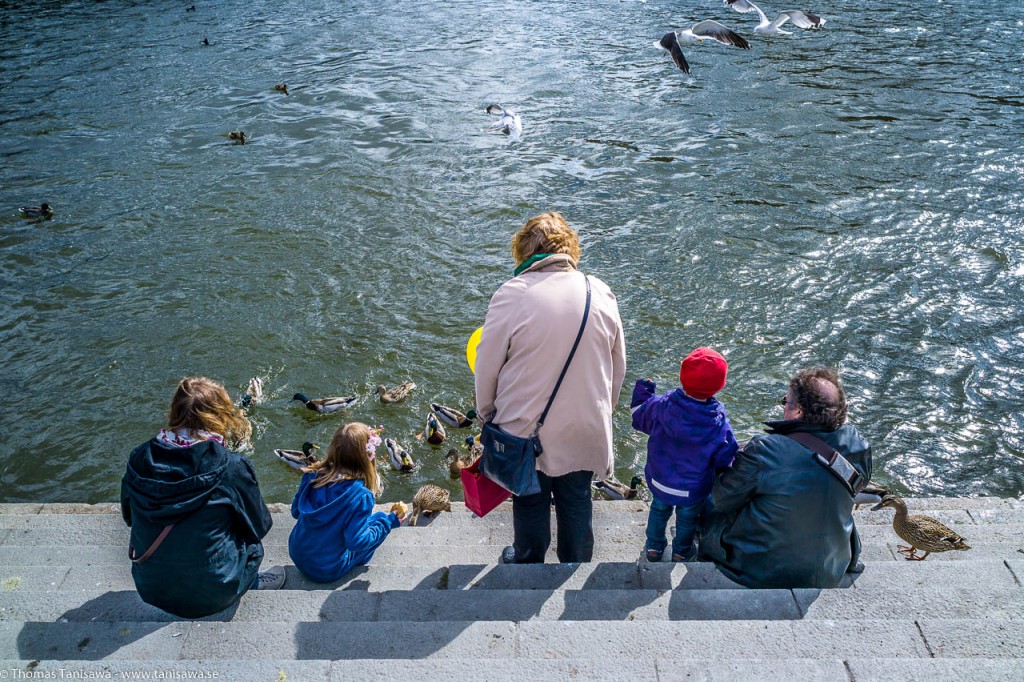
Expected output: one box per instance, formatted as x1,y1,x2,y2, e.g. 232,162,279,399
8,587,1024,623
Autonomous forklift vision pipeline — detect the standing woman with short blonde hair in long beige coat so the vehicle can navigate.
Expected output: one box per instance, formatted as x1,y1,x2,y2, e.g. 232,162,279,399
476,213,626,563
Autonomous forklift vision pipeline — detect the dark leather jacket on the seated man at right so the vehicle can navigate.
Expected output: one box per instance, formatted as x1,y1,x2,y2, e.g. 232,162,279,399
700,420,871,588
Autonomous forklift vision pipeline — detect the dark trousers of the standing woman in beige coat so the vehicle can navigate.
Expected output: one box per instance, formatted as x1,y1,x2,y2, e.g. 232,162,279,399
512,471,594,563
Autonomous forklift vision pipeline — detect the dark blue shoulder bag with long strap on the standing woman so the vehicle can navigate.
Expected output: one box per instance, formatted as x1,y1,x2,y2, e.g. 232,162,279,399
480,275,590,497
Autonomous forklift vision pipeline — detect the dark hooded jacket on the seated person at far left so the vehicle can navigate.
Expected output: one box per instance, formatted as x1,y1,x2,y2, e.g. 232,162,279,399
121,438,272,619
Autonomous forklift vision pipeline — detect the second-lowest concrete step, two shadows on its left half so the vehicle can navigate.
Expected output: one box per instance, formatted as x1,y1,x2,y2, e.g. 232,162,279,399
14,617,1024,659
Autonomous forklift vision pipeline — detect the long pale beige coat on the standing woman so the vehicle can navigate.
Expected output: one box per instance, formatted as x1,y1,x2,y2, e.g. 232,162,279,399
476,254,626,478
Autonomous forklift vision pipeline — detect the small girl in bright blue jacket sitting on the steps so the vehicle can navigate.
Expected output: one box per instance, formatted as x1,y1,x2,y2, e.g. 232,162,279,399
288,422,406,583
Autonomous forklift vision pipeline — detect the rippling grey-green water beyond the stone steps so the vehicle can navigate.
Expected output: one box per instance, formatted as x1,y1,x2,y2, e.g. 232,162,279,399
0,0,1024,502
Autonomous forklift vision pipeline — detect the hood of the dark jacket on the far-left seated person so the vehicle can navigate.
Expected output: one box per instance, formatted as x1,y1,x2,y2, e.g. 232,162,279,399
124,438,228,523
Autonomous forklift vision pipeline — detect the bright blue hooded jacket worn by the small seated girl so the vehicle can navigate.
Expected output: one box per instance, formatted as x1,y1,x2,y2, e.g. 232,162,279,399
288,473,399,583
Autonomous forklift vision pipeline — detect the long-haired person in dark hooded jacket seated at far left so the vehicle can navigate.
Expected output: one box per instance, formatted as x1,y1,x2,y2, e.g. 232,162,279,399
121,377,285,619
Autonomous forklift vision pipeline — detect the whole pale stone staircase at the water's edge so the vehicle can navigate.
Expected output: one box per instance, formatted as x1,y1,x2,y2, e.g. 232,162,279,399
0,498,1024,682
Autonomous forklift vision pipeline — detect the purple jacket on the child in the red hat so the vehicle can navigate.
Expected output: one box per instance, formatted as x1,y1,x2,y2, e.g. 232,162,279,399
630,379,739,507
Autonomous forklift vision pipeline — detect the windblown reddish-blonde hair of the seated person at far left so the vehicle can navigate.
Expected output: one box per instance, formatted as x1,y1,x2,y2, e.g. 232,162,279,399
167,377,253,443
